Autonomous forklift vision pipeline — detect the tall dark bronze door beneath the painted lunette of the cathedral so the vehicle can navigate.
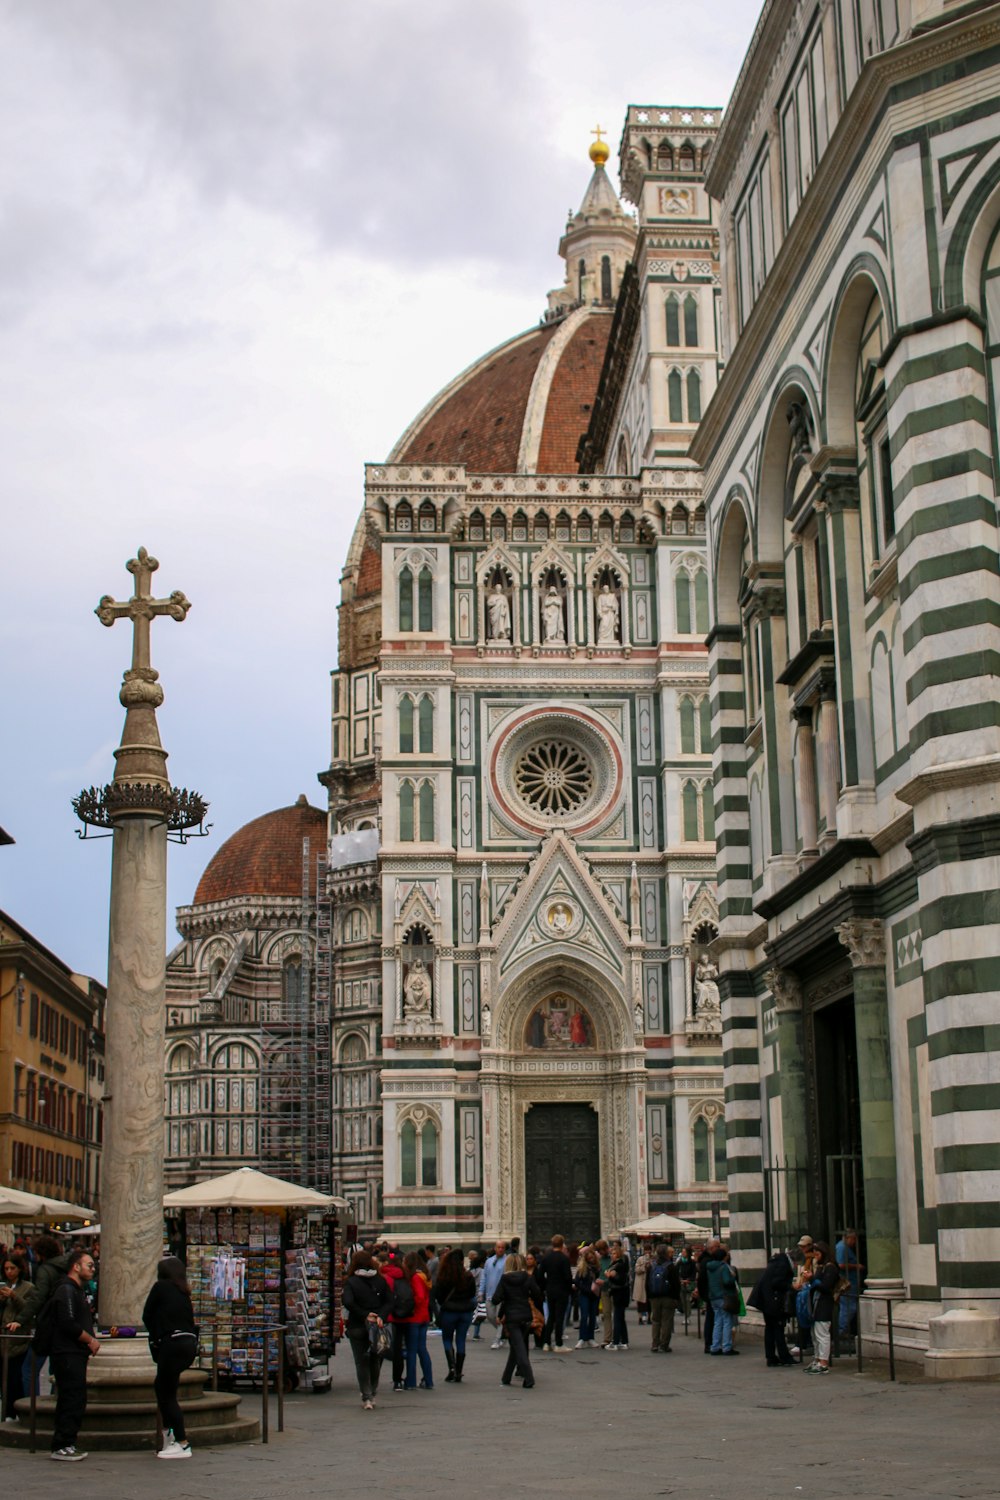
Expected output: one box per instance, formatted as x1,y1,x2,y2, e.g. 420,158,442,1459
525,1104,601,1245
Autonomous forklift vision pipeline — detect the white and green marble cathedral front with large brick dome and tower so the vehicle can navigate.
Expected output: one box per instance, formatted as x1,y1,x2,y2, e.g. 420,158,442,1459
328,120,726,1241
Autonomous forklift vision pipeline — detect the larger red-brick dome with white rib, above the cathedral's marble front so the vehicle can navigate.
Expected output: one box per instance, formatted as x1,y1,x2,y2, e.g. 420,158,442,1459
388,306,613,474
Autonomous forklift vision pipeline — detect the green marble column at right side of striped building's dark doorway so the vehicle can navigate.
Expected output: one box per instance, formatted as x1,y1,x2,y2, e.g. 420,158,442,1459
835,918,903,1290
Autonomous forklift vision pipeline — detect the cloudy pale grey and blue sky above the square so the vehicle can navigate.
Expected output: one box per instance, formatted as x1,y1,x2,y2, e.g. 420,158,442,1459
0,0,757,980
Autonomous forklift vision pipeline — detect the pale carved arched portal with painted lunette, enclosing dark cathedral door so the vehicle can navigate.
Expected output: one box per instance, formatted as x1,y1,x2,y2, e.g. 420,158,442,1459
480,953,646,1242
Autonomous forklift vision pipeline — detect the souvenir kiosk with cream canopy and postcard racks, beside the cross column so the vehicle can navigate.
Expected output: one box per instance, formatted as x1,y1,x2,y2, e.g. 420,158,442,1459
163,1167,349,1389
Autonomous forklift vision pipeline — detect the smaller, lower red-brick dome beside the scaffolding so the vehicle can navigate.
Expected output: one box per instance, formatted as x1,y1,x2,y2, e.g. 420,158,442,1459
193,797,327,906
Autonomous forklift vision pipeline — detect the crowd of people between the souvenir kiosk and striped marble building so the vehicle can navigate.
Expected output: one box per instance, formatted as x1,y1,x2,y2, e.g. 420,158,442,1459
343,1230,864,1410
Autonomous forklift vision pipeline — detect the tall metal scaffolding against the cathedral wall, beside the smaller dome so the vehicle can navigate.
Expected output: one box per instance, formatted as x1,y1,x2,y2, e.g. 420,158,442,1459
259,839,333,1193
